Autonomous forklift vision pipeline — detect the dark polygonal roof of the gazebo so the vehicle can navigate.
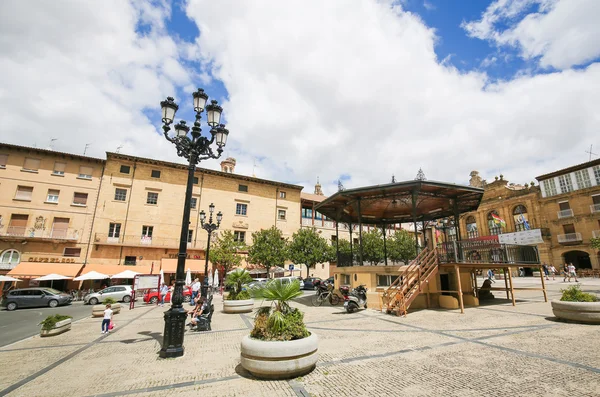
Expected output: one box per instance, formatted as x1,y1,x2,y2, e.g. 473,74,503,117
315,180,483,224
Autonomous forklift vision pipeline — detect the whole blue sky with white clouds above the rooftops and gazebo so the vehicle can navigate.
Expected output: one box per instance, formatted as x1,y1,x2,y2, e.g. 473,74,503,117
0,0,600,194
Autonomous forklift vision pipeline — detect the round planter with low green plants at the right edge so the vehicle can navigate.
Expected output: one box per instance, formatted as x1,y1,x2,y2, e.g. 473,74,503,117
552,285,600,324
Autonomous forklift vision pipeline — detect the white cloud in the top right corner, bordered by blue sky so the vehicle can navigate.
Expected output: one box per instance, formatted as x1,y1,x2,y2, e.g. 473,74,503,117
462,0,600,69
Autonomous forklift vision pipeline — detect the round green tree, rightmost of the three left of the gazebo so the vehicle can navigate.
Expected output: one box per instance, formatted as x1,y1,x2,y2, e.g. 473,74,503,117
289,228,331,277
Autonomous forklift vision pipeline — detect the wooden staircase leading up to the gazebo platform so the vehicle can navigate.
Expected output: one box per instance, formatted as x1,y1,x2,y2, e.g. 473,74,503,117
382,248,438,316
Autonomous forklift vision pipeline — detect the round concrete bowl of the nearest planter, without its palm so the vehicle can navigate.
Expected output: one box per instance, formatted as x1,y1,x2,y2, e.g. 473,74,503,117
241,334,319,379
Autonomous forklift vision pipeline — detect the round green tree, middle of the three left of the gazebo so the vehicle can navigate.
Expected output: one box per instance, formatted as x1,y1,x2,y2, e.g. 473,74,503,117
248,226,288,277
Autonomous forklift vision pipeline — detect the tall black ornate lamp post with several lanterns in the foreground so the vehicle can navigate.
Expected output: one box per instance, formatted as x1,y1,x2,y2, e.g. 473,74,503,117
159,88,229,358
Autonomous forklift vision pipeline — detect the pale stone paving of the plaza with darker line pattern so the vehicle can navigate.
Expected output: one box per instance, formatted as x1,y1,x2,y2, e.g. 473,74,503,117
0,279,600,397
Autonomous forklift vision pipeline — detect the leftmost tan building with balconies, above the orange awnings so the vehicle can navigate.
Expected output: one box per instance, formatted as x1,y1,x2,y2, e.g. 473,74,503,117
0,143,104,284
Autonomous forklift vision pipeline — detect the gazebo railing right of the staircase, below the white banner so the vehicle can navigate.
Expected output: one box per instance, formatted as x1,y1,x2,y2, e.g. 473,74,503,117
437,241,540,265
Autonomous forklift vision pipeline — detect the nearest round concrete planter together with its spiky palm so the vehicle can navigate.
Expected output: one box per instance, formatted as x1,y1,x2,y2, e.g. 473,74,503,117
241,280,319,379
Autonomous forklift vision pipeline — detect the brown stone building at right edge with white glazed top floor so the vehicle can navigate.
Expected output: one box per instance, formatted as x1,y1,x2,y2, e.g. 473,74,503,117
536,159,600,269
